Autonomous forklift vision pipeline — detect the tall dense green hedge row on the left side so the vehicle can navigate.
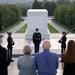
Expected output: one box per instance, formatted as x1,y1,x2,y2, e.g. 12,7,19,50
0,4,22,31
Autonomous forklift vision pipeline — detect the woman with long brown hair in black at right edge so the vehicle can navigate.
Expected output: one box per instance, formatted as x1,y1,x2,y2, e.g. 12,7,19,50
61,40,75,75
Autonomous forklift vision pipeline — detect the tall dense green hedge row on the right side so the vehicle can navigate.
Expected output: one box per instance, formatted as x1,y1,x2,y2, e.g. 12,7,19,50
54,4,75,28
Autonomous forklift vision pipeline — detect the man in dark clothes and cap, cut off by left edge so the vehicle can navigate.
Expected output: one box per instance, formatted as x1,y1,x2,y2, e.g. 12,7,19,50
0,35,10,75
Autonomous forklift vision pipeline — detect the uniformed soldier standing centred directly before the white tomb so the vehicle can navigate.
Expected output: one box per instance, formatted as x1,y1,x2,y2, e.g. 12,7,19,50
33,28,41,53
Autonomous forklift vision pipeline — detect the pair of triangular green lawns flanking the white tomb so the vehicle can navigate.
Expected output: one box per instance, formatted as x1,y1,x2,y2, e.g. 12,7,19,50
17,24,59,33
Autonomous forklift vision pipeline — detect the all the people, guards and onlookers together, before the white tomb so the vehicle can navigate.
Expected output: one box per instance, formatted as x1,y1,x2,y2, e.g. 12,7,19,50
0,28,75,75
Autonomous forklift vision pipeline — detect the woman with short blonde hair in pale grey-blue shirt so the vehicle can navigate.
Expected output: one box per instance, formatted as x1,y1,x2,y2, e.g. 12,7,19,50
17,45,36,75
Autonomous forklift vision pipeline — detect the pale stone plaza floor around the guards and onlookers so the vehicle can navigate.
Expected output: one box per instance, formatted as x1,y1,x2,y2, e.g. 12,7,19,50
2,33,75,75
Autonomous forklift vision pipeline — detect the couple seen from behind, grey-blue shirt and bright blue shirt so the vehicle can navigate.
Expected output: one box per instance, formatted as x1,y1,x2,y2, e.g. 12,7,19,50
17,40,59,75
